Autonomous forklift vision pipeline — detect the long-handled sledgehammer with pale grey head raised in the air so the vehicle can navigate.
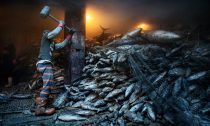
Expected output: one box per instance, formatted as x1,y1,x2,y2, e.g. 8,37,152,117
40,6,72,31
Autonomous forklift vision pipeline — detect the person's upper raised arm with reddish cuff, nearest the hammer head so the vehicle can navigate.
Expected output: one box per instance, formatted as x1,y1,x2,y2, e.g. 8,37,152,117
47,21,65,39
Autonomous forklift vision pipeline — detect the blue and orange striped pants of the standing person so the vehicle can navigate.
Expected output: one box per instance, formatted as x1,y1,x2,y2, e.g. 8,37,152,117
37,63,54,98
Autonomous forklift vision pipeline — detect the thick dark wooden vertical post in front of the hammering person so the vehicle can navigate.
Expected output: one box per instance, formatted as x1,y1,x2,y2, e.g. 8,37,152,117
65,0,85,84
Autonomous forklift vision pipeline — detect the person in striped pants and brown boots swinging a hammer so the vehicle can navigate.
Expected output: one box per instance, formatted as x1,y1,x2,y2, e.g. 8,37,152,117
35,21,74,116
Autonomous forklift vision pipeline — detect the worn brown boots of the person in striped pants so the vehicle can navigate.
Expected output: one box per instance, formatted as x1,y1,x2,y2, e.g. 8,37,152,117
35,97,55,116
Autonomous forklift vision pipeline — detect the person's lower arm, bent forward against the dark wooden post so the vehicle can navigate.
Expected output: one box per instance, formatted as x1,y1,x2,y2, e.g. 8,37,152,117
54,30,75,50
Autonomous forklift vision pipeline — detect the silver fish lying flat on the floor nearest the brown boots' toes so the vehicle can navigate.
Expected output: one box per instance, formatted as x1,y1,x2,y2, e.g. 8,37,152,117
58,113,87,121
